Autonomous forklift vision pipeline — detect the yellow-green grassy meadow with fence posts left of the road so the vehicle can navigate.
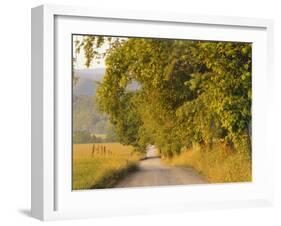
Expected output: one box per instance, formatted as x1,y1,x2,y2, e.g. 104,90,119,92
73,143,141,190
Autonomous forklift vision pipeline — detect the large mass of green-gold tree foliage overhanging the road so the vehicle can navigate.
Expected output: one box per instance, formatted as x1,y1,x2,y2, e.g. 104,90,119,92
79,38,252,156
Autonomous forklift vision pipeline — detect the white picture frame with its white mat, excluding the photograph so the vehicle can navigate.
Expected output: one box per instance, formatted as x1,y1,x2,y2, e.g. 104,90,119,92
31,5,273,220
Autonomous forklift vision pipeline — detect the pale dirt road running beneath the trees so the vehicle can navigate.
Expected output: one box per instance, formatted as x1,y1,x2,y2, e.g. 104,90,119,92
116,146,207,188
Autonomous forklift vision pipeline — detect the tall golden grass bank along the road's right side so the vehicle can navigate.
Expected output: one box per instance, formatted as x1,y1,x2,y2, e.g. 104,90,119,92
166,144,252,183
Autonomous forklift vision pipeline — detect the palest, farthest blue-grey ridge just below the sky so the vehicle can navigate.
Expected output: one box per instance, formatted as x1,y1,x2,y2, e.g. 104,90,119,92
73,68,105,96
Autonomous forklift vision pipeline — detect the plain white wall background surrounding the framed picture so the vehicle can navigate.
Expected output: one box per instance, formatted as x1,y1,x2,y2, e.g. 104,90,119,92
0,0,281,226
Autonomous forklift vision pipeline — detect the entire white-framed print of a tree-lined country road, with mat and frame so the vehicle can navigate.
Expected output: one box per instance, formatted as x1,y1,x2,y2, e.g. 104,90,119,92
32,5,273,220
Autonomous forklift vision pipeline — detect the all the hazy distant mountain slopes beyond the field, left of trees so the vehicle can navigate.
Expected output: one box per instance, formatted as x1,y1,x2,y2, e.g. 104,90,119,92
73,68,140,135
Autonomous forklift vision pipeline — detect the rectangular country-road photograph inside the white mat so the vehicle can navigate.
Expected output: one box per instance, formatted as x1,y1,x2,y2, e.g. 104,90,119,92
69,34,250,190
